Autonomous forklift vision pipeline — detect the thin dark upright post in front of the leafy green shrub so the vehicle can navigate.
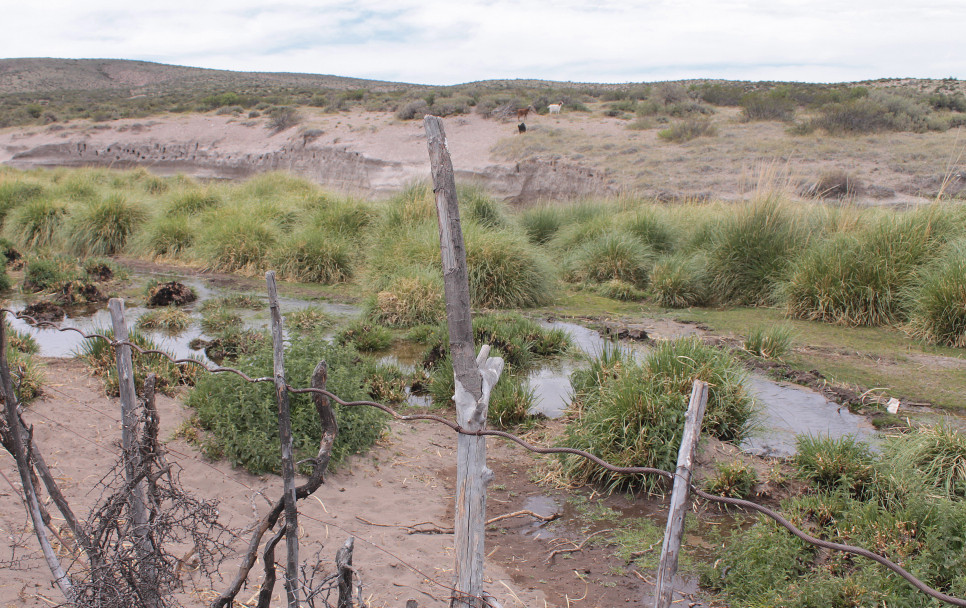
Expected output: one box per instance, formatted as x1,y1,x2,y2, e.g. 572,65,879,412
265,270,299,608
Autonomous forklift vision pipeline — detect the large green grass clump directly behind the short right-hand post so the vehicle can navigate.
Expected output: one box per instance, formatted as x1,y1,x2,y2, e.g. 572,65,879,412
562,338,755,489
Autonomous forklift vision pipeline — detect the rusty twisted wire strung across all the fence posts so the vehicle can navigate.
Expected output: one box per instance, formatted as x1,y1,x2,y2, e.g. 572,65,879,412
0,308,966,608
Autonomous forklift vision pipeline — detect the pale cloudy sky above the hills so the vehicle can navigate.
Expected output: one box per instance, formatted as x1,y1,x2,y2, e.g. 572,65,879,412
0,0,966,84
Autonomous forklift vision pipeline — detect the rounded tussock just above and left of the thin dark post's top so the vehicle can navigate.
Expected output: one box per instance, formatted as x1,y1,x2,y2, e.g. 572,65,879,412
199,211,278,272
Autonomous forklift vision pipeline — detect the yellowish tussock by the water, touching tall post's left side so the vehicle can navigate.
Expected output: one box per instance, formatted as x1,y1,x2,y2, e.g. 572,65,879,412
366,267,446,327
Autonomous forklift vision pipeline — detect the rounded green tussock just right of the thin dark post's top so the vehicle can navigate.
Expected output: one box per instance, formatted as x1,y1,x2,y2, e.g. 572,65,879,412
270,230,355,285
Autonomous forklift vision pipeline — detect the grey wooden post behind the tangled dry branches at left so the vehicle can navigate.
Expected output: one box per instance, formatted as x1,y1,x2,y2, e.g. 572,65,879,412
107,298,161,607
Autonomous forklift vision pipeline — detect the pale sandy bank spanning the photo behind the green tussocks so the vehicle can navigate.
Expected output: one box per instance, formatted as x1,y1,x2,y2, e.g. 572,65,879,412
0,108,966,205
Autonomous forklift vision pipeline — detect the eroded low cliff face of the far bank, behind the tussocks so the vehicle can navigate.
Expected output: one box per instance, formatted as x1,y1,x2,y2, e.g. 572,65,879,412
7,140,615,203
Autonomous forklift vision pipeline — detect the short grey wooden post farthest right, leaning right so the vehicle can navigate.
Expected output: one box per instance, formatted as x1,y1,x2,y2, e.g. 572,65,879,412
654,380,708,608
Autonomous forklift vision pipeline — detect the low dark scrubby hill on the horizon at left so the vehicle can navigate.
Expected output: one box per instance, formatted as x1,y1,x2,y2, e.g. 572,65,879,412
0,58,412,95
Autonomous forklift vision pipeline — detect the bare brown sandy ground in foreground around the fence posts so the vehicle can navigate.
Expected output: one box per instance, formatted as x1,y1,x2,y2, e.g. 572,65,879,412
0,359,702,608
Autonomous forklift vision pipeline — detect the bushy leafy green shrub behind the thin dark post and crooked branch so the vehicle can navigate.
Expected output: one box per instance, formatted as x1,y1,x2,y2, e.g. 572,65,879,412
187,337,388,474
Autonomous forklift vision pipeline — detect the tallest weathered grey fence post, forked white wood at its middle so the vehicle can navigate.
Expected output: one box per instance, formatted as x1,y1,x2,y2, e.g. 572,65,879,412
423,116,503,608
